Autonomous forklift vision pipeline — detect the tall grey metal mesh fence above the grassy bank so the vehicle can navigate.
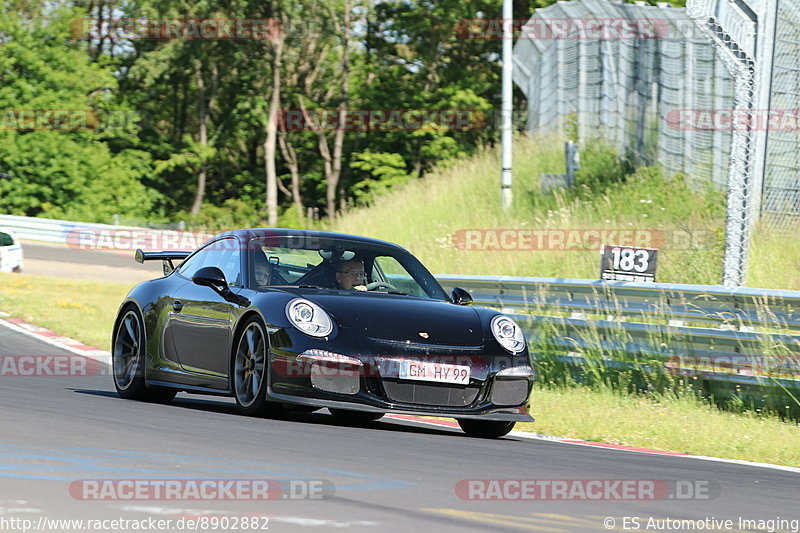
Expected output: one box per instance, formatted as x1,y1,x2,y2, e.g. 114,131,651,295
514,0,800,286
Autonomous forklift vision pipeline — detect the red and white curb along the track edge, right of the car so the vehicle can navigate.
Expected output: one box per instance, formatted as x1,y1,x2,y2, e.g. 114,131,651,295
386,414,800,474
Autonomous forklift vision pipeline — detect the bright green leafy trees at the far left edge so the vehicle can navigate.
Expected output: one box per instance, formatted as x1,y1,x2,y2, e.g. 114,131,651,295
0,8,159,222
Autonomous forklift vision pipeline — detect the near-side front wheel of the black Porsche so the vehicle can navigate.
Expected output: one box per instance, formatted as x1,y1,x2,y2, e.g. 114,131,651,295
230,316,283,416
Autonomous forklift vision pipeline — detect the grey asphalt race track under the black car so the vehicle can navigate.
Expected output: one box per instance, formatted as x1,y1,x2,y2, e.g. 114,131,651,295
0,326,800,532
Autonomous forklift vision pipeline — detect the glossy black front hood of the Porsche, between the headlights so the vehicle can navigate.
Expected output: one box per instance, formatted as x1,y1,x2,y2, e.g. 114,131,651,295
294,291,483,346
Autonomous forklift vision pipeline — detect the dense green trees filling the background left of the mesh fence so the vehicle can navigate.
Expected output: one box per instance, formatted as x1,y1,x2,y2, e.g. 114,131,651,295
0,0,688,226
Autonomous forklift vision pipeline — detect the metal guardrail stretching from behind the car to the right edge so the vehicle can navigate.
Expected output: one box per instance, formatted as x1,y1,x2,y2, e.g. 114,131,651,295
436,275,800,388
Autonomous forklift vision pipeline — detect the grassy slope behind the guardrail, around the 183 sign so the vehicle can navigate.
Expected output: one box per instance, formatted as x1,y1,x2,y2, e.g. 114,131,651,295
325,132,725,284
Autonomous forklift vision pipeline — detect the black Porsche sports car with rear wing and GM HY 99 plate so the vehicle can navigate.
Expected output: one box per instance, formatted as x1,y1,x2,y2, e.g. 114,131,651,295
112,229,533,437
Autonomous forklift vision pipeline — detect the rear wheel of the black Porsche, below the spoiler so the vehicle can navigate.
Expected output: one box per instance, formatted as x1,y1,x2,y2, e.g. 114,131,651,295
111,306,177,403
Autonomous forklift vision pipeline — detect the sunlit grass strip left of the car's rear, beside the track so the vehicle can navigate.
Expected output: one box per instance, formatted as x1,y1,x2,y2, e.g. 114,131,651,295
0,274,133,350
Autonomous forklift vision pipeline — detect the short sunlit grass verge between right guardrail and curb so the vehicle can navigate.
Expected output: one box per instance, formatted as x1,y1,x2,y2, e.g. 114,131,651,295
517,387,800,466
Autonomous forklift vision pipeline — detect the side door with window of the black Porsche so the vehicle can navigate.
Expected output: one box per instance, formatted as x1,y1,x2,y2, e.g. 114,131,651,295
167,238,241,378
